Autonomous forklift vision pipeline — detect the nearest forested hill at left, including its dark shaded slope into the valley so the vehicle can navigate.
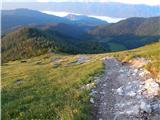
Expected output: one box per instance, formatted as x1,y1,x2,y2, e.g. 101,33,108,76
2,24,104,62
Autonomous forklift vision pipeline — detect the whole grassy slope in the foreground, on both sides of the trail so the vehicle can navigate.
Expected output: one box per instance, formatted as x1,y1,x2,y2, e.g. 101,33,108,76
2,42,160,120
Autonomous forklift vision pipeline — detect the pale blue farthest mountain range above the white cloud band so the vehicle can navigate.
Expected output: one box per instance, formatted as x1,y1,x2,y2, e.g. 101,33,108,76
2,2,160,18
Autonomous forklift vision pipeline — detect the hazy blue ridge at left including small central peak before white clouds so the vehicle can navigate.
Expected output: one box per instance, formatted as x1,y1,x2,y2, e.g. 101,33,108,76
1,9,107,33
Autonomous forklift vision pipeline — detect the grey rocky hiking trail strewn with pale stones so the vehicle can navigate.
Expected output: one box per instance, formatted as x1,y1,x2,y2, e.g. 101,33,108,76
90,58,160,120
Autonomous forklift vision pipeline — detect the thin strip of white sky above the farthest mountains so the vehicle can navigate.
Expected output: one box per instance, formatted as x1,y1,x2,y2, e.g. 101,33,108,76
2,0,160,5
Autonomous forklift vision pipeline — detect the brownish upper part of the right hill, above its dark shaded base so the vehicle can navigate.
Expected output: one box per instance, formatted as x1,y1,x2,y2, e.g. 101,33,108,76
90,17,160,37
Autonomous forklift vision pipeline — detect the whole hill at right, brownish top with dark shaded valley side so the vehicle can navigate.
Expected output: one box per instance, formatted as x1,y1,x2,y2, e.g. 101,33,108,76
88,17,160,49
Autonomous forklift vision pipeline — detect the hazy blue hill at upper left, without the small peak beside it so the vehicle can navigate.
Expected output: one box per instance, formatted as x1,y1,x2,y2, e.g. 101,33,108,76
2,9,70,33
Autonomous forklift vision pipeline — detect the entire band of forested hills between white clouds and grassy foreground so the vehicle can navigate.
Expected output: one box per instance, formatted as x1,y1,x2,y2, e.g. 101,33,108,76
2,9,160,62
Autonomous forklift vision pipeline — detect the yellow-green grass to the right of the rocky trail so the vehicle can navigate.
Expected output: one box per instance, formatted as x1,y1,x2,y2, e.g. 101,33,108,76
110,41,160,77
